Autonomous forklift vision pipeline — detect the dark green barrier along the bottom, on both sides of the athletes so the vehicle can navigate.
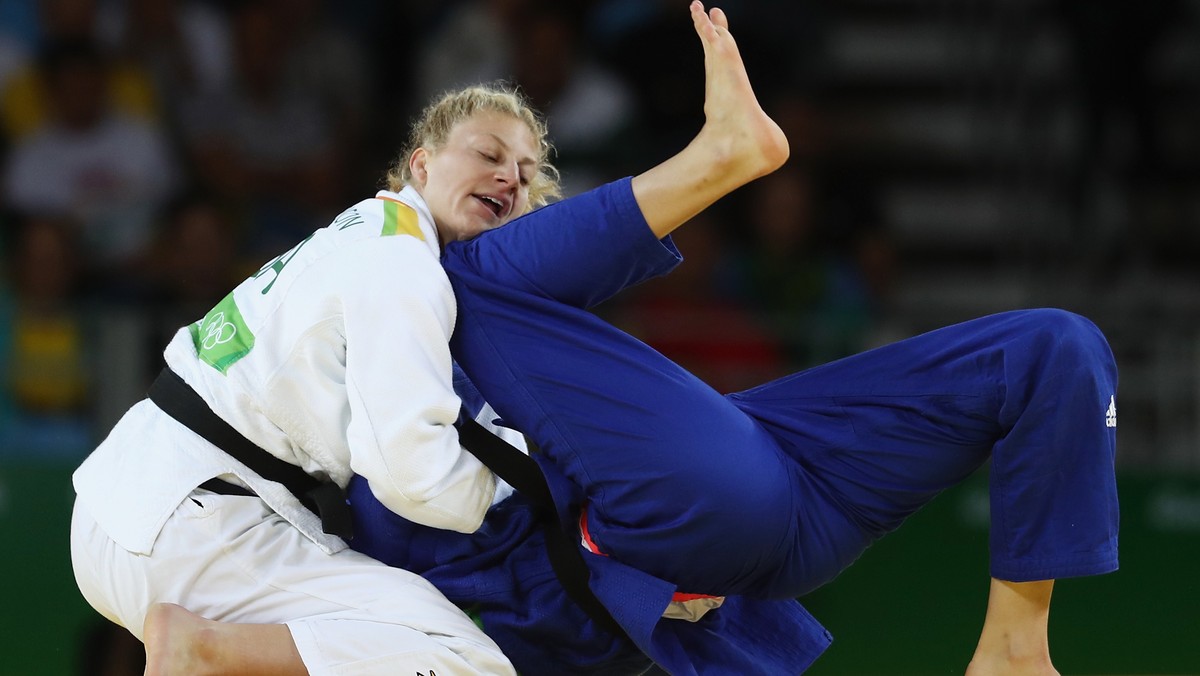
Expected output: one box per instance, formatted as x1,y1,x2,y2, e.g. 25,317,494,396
0,457,1200,676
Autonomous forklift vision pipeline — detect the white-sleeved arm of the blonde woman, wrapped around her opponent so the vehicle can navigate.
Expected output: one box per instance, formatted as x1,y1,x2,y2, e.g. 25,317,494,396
343,237,496,533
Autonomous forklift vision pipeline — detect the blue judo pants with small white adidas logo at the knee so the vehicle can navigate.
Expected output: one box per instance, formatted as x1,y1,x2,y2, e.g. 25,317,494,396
443,180,1117,599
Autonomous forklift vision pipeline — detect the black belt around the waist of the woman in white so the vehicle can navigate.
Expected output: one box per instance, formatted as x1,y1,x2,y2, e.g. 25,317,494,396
149,369,354,540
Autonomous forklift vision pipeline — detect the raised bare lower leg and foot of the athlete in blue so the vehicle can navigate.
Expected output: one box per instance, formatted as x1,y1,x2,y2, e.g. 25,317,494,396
634,0,788,238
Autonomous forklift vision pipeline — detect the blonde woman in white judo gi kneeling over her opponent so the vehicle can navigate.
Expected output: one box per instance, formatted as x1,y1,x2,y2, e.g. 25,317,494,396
71,71,557,675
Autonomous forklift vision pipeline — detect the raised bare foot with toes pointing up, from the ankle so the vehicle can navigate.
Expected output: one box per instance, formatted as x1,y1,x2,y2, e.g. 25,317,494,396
690,0,790,183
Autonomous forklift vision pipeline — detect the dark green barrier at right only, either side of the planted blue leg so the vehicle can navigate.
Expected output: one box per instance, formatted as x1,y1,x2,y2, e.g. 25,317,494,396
804,474,1200,675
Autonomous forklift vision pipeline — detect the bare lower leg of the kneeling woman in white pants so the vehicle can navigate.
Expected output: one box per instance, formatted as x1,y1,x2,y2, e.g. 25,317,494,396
143,603,308,676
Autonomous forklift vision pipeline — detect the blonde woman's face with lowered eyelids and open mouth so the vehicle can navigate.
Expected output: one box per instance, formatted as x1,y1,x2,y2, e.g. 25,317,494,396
409,110,539,243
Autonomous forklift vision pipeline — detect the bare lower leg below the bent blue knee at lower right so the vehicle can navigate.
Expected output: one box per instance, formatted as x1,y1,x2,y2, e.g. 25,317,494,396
967,578,1058,676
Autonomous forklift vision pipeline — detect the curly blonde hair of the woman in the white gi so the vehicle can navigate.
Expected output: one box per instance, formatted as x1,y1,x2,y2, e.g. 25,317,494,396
385,83,563,209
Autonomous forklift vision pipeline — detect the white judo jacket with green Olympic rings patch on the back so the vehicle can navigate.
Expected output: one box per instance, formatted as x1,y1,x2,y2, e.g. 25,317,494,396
73,187,523,555
